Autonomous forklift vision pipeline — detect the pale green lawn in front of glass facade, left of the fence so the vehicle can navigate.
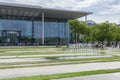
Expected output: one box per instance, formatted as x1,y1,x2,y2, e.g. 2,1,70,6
0,46,65,56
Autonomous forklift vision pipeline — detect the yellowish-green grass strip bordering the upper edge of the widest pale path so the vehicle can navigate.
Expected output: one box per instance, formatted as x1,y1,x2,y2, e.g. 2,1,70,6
0,56,120,69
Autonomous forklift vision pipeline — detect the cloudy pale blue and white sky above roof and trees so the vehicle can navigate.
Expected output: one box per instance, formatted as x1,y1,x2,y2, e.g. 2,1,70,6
0,0,120,24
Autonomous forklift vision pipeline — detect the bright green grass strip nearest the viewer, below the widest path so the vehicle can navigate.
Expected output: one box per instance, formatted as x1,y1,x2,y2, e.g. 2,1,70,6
2,69,120,80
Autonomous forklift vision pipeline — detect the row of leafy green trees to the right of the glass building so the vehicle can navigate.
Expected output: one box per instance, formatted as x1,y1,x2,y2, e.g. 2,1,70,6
68,20,120,42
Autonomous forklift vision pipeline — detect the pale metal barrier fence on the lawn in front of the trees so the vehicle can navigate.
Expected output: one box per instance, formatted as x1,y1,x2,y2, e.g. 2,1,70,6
65,43,120,54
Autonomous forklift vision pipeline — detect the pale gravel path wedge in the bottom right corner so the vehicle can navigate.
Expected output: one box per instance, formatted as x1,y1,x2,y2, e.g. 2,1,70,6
57,73,120,80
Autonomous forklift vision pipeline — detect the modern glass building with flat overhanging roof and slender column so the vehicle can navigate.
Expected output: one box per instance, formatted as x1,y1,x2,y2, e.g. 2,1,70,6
0,3,91,45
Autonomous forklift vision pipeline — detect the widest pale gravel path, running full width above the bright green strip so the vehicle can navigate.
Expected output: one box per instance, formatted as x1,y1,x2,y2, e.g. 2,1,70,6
0,62,120,80
